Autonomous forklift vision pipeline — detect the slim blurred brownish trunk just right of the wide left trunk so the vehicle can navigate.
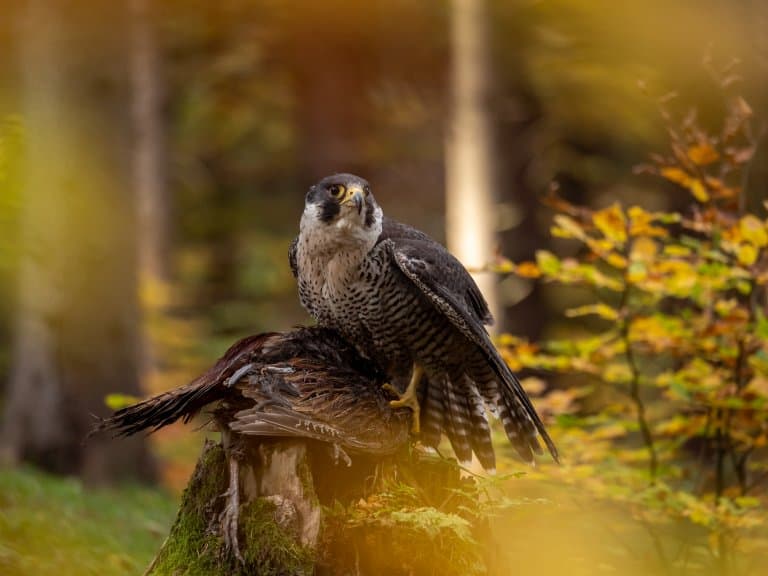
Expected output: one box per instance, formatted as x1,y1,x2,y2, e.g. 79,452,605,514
129,0,169,382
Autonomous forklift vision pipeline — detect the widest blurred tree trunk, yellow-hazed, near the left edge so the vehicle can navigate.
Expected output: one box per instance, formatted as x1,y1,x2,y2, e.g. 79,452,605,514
2,0,153,481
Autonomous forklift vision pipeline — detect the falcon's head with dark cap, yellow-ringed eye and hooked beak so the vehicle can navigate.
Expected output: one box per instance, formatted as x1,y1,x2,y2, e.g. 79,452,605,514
302,174,382,237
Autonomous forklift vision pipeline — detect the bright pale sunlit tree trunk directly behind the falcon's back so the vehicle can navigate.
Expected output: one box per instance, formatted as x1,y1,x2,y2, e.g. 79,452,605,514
445,0,498,328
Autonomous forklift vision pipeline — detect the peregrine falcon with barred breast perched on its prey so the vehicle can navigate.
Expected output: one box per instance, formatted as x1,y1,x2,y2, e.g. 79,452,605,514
289,174,558,470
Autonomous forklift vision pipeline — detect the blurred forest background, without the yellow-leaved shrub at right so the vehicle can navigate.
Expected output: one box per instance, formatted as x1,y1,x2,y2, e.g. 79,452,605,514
0,0,768,575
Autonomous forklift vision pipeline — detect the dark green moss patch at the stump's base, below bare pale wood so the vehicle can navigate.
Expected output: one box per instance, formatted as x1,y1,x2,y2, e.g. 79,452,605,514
238,498,314,576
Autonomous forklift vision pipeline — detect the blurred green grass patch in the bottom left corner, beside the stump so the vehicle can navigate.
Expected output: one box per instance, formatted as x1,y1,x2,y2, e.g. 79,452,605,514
0,468,178,576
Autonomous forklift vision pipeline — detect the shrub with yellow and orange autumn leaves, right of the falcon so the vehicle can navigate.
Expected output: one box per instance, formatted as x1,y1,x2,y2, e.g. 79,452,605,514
501,89,768,574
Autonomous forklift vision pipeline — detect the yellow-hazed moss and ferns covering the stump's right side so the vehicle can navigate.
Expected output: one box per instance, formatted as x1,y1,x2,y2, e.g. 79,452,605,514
322,458,488,576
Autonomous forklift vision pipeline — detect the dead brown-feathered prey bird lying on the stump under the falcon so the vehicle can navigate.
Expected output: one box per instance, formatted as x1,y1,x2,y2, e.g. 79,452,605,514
92,328,408,454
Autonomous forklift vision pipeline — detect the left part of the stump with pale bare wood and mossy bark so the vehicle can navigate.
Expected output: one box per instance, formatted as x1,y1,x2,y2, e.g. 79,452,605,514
145,441,320,576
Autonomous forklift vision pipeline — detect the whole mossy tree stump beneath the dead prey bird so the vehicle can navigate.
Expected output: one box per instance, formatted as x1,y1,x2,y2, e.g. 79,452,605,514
145,433,490,576
